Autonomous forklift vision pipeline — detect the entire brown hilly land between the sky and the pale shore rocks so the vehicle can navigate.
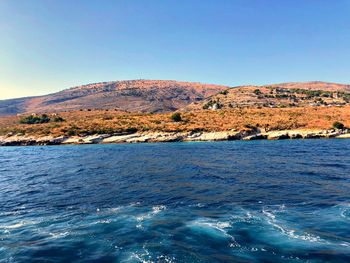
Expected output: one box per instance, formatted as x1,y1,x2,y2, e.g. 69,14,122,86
0,80,350,145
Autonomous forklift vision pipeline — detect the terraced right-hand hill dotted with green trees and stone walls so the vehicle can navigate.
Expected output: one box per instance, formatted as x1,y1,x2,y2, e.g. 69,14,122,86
186,82,350,110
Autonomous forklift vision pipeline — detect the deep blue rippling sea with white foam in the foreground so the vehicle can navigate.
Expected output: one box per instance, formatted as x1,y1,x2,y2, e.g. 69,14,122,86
0,140,350,262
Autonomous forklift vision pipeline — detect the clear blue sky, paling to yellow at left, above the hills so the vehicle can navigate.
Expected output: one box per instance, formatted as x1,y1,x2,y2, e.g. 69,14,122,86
0,0,350,99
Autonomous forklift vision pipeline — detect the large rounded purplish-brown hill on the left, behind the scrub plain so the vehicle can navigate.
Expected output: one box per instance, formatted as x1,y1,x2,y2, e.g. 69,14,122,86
0,80,227,116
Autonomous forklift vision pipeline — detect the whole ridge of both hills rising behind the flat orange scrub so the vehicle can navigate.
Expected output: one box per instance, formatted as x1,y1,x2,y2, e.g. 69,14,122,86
0,80,350,116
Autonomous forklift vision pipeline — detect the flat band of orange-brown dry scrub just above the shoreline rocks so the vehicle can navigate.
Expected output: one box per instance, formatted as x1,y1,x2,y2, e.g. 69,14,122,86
0,106,350,136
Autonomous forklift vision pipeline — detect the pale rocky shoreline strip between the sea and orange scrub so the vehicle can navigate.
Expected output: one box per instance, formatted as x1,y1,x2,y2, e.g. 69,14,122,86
0,129,350,146
